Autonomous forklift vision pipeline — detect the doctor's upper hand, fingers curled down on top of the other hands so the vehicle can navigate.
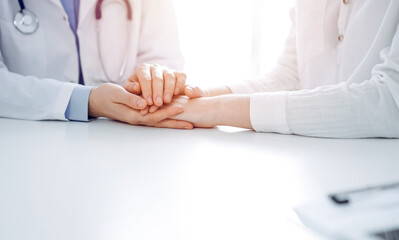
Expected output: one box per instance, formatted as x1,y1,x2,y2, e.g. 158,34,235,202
123,64,186,109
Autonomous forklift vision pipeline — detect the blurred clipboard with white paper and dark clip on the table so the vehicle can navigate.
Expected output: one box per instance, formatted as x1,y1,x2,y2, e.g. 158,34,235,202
294,183,399,240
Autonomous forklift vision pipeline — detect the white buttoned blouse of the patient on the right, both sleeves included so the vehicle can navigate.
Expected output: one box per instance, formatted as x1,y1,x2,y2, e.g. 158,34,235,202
229,0,399,138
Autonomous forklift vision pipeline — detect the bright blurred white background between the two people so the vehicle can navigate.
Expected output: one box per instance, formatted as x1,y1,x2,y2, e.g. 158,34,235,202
174,0,293,86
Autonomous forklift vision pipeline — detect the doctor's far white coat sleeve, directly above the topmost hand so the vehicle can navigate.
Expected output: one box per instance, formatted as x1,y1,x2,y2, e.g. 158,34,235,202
137,0,184,71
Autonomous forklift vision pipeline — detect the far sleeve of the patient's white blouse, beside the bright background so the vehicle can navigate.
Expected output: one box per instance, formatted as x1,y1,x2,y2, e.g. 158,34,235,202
228,9,299,94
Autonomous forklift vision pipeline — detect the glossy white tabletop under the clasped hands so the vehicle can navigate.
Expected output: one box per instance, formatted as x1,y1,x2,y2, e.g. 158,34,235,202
0,119,399,240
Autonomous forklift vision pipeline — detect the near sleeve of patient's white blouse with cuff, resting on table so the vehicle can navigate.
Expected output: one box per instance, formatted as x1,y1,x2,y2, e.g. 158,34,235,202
251,26,399,138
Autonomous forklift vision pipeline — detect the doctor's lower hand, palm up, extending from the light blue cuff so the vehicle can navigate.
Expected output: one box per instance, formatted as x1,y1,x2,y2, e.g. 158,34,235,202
89,83,193,129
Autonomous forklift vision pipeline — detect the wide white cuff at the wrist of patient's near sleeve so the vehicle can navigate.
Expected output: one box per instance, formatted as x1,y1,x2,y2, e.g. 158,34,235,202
250,92,292,134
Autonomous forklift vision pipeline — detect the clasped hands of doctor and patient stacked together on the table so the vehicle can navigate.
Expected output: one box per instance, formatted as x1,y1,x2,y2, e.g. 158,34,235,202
89,64,212,129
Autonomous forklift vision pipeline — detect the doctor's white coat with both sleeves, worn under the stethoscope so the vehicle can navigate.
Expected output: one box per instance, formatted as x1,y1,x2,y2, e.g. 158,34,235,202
0,0,183,120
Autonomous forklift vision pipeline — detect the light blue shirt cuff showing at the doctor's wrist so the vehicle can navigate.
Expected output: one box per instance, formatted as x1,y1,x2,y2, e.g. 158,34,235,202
65,85,93,122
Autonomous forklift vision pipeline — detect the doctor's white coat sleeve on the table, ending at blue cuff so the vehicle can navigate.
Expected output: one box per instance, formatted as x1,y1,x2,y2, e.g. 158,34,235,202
0,52,76,120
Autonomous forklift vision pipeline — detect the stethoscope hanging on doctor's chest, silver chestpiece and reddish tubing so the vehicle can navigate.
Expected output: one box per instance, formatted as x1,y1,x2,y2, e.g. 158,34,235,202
14,0,133,83
